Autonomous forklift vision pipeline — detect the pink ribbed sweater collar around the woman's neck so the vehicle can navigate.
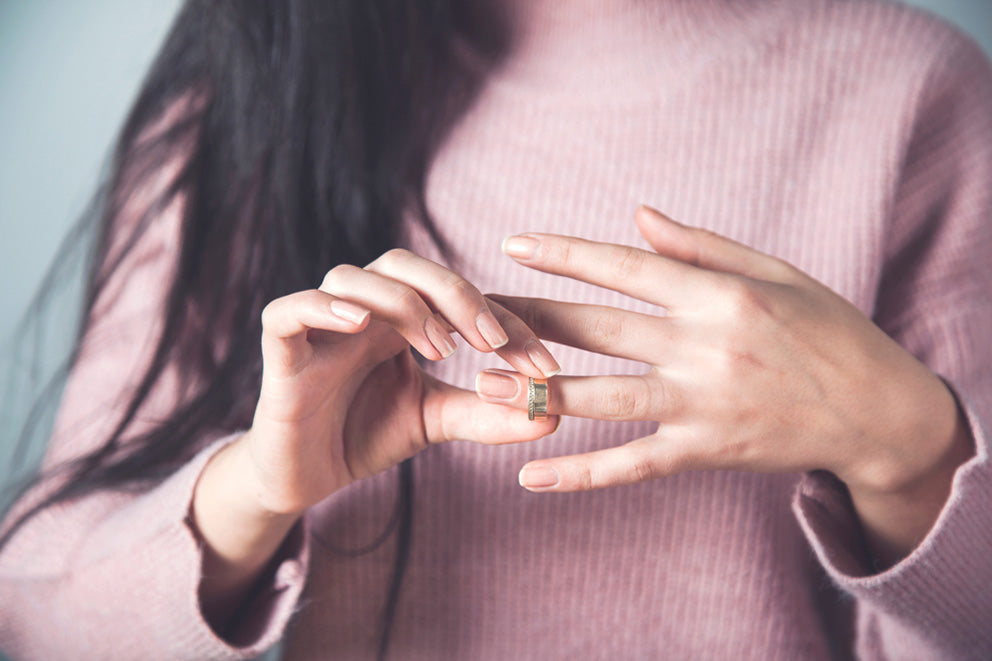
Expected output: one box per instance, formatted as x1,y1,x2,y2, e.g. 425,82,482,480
456,0,803,100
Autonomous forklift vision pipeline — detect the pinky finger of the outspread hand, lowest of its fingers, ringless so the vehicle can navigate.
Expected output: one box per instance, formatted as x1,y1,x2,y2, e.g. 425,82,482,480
519,436,687,492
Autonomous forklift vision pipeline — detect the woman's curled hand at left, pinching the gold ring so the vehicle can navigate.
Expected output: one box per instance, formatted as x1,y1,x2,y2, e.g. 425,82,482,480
238,249,559,513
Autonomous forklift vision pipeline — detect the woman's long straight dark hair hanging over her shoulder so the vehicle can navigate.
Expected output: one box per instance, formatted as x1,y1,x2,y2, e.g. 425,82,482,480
0,0,488,655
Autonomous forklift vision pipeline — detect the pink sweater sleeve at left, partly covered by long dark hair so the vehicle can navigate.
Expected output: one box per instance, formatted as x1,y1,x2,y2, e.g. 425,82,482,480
0,157,309,659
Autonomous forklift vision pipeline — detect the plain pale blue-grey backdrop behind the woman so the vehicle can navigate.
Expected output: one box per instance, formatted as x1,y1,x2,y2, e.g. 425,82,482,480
0,0,992,456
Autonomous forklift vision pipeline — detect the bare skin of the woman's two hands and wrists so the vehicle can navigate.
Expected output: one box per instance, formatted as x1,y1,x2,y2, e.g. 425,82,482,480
192,207,974,635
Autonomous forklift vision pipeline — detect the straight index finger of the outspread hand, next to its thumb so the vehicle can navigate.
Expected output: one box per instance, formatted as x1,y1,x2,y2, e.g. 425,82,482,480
503,233,721,309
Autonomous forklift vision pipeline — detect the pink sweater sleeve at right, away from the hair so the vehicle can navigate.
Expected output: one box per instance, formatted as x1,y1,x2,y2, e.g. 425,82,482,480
793,27,992,659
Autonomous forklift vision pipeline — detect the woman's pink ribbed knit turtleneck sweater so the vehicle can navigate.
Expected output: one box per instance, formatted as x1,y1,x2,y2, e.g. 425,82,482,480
0,0,992,659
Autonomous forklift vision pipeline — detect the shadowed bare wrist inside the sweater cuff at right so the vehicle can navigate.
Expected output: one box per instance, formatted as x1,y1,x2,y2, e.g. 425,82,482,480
848,398,975,569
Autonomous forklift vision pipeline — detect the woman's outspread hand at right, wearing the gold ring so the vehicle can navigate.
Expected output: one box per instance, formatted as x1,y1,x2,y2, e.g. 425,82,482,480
477,207,971,555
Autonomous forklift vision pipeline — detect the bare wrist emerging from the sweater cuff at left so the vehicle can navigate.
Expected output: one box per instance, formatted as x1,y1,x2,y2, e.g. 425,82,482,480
192,437,300,633
